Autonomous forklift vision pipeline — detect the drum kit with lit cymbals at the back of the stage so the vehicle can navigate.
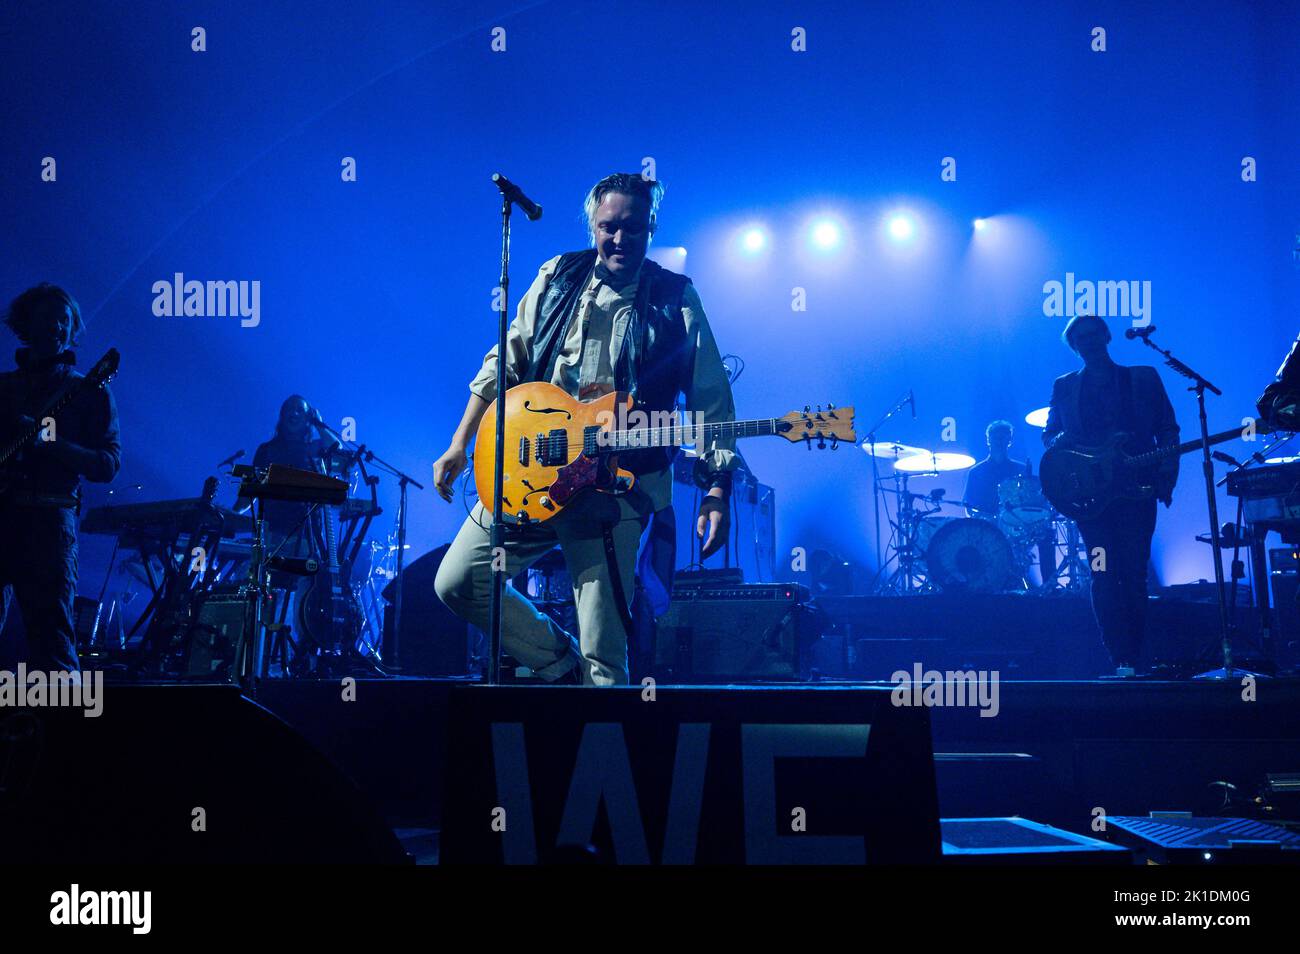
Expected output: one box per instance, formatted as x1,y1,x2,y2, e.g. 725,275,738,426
861,408,1089,595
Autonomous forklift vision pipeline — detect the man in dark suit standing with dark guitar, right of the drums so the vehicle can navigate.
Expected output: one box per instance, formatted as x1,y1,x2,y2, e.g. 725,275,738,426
1043,315,1178,677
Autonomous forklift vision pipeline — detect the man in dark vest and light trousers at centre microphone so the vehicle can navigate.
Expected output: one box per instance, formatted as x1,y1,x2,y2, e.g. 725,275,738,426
433,173,737,686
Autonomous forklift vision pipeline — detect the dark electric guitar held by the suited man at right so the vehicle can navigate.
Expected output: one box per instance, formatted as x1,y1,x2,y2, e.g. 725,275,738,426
1039,421,1270,520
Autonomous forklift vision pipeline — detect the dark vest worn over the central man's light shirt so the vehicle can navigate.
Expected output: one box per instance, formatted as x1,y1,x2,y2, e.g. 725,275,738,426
527,248,694,472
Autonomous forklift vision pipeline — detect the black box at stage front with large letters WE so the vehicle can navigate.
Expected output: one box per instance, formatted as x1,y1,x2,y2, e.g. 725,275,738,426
442,686,940,864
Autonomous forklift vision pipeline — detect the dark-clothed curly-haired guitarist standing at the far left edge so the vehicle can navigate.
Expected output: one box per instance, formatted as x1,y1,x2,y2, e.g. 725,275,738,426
0,283,122,672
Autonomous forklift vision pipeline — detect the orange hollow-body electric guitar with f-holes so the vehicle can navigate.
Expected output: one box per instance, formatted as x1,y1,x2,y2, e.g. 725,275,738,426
475,381,857,522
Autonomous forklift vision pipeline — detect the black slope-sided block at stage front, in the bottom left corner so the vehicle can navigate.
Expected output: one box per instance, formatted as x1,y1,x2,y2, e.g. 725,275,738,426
0,685,406,864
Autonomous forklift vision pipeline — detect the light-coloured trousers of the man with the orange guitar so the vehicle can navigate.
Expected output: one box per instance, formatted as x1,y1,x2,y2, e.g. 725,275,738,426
434,491,650,686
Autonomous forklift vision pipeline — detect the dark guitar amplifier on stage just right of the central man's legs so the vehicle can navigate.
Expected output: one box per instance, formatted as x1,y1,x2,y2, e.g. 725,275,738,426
654,584,820,682
